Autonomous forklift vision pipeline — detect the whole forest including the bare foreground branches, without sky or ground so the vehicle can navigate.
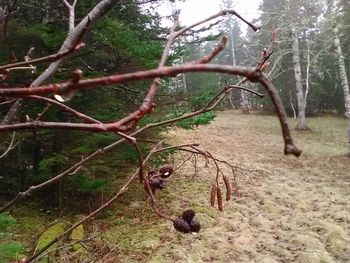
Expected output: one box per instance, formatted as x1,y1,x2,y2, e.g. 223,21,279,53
0,0,350,262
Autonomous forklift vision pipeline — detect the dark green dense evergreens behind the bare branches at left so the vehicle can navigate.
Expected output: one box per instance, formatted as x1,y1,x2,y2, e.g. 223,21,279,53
0,0,178,201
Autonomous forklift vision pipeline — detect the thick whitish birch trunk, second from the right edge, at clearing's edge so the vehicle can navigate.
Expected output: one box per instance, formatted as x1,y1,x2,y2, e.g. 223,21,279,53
291,25,306,130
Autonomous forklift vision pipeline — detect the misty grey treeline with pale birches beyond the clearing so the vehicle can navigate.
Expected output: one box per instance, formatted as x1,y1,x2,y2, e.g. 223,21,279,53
186,0,350,134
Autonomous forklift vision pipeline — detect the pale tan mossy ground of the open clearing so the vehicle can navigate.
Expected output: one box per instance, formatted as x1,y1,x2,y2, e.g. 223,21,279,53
102,111,350,263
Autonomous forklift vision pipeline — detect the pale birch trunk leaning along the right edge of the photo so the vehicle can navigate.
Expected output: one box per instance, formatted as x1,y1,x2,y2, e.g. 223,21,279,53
333,26,350,143
